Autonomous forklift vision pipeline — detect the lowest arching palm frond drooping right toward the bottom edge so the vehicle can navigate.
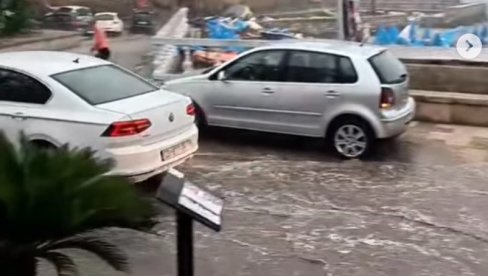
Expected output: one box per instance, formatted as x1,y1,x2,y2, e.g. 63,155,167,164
43,235,130,273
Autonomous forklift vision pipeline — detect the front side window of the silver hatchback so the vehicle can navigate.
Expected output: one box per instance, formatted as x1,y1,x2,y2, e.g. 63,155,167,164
225,51,285,81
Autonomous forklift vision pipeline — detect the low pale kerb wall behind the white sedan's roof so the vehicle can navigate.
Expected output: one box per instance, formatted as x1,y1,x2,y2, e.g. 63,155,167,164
0,31,83,52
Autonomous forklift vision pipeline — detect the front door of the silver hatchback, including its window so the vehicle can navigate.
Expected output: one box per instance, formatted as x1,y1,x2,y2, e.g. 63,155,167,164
206,50,285,131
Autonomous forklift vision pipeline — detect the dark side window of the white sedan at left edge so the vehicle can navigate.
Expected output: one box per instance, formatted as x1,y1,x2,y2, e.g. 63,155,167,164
0,69,51,104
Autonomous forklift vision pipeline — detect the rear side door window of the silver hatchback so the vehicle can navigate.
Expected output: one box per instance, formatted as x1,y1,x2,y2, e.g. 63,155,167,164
286,51,357,83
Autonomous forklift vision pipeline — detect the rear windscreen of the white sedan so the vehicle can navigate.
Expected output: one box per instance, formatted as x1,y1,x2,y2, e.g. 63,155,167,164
51,65,158,105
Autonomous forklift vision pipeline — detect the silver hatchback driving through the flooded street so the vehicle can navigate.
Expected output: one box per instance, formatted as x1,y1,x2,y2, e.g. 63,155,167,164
165,42,415,158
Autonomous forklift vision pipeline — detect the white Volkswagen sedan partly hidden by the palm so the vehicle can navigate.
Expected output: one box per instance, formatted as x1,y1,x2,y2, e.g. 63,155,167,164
0,51,198,182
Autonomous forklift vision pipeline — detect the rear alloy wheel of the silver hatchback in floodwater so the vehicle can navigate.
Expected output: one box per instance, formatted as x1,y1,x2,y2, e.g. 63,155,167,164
334,124,369,158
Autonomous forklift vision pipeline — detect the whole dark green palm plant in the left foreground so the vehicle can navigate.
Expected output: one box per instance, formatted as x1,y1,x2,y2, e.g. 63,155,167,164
0,135,153,276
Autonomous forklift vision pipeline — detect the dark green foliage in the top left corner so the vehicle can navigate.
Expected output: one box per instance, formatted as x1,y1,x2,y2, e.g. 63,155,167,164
0,0,30,36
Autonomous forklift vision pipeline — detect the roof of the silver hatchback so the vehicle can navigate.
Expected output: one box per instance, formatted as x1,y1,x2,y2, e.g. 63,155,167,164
254,40,386,58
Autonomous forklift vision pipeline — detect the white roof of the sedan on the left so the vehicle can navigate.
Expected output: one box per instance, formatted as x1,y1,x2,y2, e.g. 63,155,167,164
0,51,110,76
